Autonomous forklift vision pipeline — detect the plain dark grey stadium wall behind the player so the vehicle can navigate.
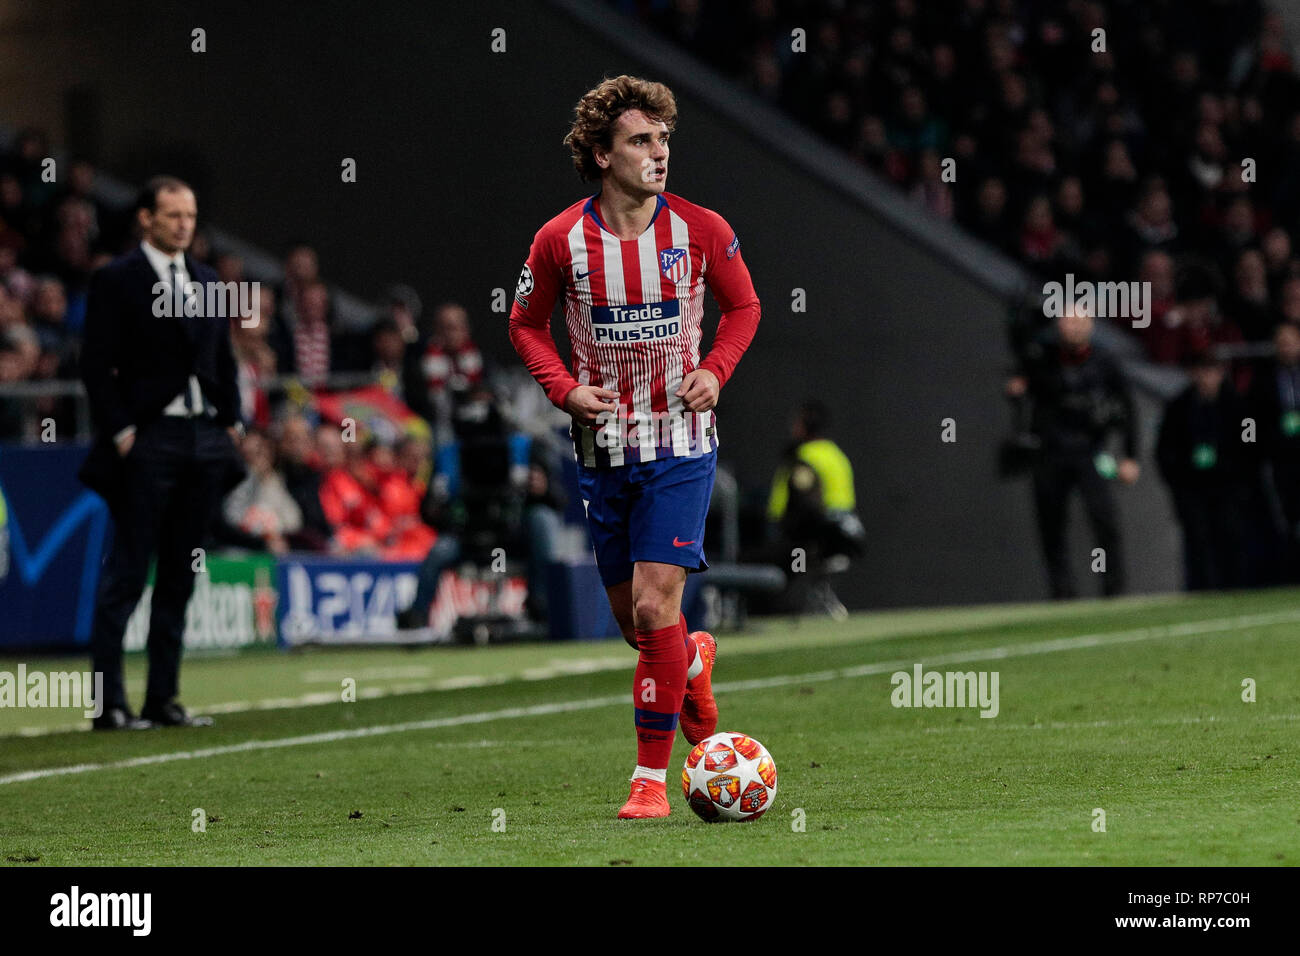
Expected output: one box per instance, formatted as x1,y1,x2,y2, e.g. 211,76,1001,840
0,0,1177,606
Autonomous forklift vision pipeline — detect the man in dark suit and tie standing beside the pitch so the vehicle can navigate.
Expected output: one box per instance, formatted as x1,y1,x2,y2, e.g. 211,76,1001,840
81,177,243,730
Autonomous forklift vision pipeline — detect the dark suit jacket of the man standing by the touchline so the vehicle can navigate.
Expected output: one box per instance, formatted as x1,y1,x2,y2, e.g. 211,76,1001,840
79,247,243,507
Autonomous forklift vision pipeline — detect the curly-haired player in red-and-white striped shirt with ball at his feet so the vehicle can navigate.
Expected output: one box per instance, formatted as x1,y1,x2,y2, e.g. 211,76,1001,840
510,75,759,819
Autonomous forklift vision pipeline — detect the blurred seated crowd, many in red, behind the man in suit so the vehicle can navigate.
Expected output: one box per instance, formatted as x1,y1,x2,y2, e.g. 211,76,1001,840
0,129,563,626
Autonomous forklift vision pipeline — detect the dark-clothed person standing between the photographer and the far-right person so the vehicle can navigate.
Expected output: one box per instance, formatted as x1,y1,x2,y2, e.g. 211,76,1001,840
1156,351,1253,591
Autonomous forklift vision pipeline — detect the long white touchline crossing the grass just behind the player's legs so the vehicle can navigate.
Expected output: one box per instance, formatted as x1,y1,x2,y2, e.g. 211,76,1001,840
0,611,1300,786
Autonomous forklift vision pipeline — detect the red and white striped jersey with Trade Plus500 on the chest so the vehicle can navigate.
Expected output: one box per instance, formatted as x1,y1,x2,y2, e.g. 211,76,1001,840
510,193,759,468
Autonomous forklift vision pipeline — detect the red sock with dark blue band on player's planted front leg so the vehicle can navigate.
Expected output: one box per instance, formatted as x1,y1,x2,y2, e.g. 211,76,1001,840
632,622,690,770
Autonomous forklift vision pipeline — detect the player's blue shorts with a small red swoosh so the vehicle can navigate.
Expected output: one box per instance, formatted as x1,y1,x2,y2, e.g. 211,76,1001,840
577,453,718,588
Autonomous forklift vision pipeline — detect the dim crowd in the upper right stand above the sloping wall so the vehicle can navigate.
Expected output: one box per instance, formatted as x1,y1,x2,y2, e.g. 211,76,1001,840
610,0,1300,364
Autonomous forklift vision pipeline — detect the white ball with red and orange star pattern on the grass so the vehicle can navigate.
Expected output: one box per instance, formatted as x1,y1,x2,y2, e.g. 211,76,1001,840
681,734,776,823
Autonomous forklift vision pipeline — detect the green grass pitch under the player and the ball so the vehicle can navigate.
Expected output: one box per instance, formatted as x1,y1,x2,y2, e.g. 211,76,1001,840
0,591,1300,866
